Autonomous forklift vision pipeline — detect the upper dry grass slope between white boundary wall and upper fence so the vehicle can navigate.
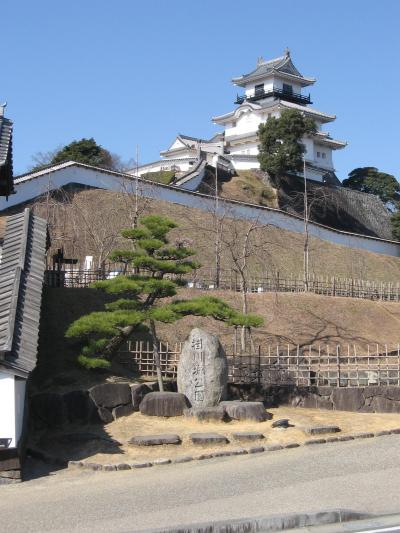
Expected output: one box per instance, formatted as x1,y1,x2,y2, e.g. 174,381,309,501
14,189,400,282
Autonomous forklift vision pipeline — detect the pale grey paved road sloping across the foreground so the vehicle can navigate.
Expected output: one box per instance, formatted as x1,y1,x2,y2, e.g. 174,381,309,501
0,435,400,533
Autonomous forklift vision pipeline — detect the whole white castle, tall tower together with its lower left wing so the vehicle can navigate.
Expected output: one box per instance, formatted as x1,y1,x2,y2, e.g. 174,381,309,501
133,50,346,183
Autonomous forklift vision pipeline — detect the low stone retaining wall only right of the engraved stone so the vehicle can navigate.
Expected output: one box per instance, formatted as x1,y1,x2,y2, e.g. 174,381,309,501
228,383,400,413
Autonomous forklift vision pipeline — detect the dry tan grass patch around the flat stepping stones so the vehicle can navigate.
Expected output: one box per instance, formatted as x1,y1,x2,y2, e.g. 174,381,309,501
45,407,400,463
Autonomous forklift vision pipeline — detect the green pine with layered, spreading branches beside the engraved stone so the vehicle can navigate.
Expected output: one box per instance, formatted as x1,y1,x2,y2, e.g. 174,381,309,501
66,216,262,390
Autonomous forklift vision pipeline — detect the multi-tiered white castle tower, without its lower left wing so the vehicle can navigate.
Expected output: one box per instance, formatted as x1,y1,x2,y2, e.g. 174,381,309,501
212,50,346,183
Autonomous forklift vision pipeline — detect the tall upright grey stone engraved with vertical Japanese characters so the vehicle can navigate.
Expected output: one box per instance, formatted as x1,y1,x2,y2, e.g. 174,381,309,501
178,328,228,407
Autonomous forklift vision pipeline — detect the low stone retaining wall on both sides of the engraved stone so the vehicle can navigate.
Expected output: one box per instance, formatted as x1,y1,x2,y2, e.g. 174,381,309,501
30,382,400,432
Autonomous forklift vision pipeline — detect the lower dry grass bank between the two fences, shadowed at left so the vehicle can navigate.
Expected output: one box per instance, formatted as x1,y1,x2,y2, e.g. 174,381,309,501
33,289,400,390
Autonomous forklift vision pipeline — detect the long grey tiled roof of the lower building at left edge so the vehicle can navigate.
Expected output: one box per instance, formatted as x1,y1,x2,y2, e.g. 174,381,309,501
0,209,47,375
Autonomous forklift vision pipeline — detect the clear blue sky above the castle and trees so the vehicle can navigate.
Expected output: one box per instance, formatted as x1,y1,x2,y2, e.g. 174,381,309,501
0,0,400,179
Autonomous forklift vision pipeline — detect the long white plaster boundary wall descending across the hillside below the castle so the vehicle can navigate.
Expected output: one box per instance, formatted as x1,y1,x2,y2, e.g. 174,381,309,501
0,166,400,257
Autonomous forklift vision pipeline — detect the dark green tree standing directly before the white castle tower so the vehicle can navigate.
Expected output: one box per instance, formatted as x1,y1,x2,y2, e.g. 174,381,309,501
258,109,316,180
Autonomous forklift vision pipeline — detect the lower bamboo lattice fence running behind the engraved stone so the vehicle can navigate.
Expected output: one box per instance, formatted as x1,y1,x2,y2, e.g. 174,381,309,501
119,341,400,387
